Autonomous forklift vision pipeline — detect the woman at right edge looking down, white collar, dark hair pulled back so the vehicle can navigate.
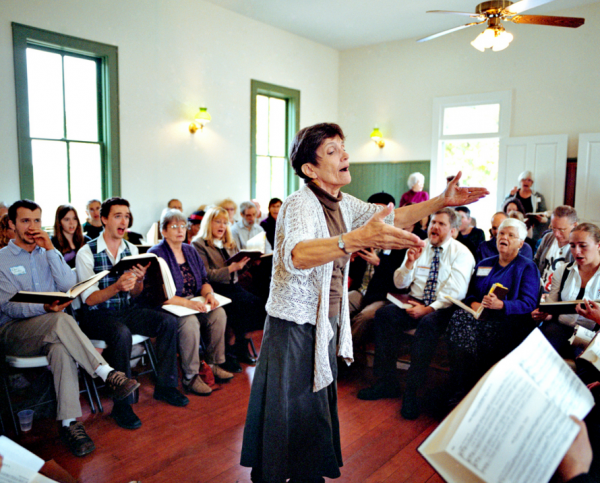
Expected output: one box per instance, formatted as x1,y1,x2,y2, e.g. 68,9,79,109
533,223,600,357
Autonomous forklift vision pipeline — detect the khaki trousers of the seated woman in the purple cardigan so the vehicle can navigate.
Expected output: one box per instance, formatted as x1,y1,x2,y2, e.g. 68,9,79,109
177,307,227,375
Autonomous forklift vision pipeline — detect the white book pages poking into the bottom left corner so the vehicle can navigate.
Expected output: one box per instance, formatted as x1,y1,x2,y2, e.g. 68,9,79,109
0,436,54,483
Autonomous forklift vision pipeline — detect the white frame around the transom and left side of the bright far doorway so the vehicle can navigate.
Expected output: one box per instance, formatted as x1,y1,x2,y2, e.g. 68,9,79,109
429,90,512,193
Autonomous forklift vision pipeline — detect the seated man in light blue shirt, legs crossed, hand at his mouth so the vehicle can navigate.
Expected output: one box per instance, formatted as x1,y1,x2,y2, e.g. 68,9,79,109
0,200,139,456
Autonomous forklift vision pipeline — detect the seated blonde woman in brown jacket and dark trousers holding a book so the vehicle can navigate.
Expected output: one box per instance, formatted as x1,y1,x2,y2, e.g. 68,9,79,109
192,206,266,372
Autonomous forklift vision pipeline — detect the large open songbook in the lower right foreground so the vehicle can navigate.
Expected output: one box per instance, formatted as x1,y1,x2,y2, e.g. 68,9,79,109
419,329,594,483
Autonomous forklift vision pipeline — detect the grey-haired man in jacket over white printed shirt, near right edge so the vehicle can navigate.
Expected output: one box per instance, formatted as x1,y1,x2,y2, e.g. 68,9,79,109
533,205,577,293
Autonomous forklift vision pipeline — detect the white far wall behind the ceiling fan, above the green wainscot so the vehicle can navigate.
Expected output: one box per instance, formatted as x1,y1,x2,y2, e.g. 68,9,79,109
339,3,600,166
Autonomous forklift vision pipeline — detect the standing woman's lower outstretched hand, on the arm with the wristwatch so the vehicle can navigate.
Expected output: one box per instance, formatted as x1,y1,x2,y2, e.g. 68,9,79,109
354,203,425,250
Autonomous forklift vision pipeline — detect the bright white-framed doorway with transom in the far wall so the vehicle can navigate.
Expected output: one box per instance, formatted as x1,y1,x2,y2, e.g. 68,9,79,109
431,91,511,234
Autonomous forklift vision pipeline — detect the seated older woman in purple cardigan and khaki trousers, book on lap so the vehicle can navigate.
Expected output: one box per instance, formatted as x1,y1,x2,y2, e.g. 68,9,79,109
148,209,233,396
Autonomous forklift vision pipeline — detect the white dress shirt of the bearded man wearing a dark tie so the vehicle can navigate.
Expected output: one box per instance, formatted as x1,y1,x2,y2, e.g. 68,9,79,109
394,236,475,310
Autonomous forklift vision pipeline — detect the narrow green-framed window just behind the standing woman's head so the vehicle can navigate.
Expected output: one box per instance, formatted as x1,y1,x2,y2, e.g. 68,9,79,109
250,80,300,213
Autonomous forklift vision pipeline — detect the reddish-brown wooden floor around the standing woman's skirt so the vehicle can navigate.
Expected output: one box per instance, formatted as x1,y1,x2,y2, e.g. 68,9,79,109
11,333,443,483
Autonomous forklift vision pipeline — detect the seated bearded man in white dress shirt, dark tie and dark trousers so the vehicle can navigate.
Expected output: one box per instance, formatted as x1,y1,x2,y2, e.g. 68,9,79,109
358,208,475,419
